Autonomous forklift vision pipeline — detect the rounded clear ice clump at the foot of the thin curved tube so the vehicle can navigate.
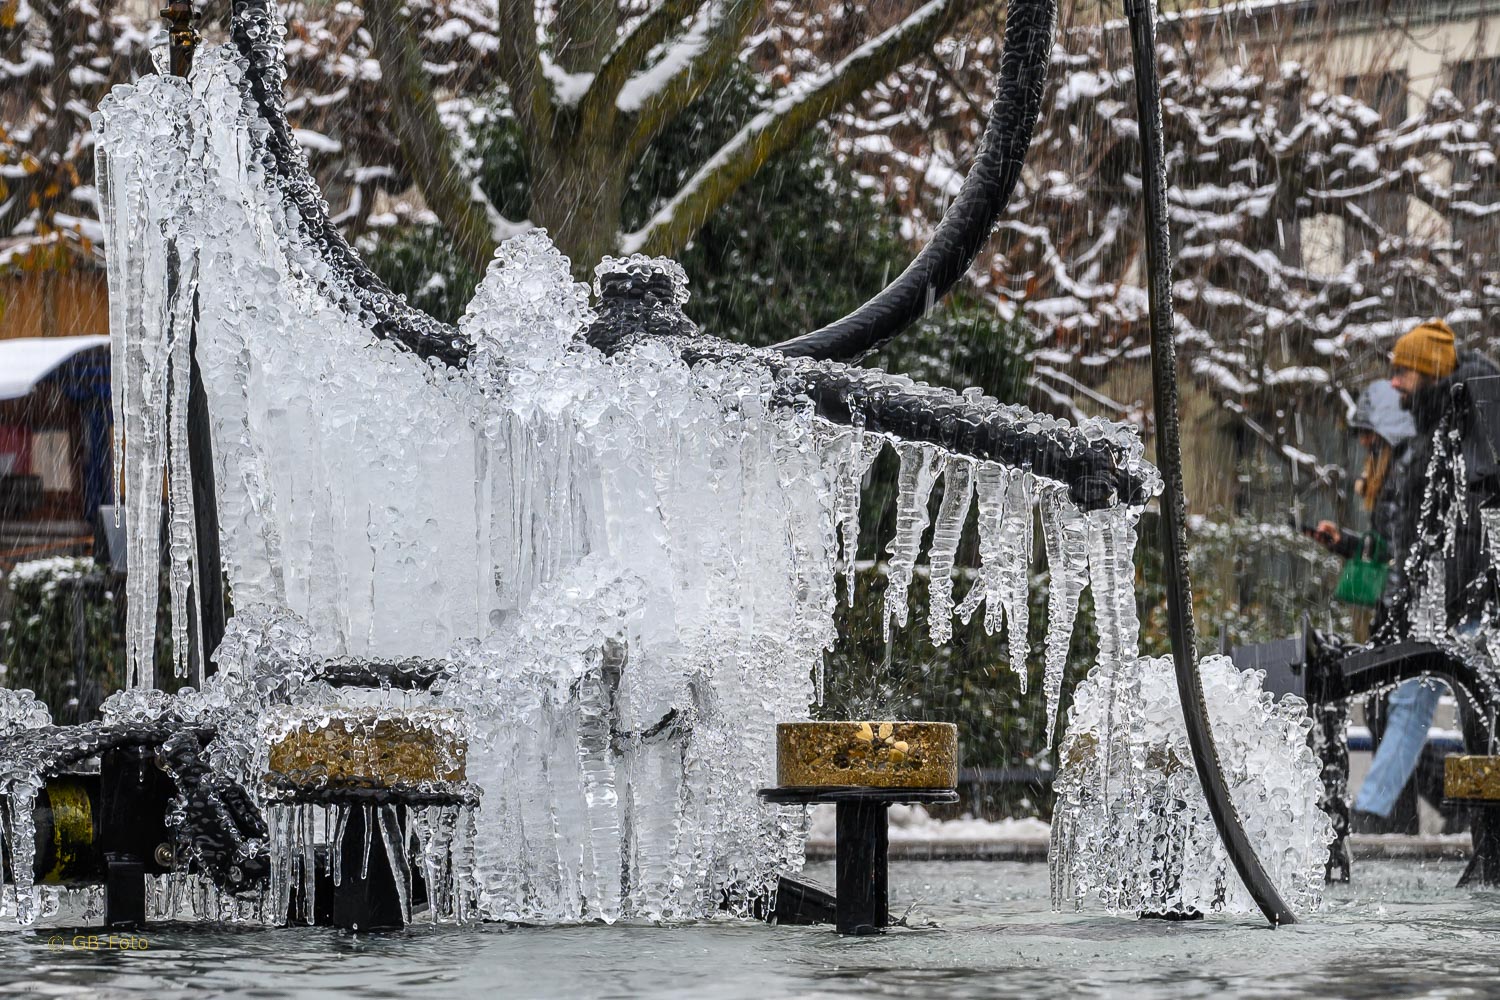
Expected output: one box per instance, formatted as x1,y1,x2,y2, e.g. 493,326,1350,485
1050,513,1334,915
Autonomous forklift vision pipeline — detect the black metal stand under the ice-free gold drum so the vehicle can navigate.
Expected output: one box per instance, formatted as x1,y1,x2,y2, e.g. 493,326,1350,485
761,786,959,936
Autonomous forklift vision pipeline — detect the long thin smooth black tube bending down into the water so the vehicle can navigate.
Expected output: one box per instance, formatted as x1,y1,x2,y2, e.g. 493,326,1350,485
1125,0,1298,927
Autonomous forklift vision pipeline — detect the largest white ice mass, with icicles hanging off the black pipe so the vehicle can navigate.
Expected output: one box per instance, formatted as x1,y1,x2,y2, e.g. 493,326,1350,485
0,21,1326,922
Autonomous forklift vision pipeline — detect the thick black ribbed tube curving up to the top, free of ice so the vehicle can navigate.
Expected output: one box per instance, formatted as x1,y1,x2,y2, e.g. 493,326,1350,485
776,0,1058,361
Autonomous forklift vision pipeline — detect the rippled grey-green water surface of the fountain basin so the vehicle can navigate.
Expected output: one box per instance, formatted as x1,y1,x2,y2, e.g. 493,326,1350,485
0,861,1500,1000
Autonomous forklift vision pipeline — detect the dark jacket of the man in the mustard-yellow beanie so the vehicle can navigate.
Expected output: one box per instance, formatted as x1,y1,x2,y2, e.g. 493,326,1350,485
1380,351,1500,631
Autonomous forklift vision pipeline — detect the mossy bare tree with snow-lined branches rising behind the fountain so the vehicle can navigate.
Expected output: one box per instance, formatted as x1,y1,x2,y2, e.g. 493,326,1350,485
363,0,996,270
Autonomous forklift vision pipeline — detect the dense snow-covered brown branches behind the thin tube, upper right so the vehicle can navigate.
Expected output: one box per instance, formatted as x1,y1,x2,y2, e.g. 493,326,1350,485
816,13,1500,472
